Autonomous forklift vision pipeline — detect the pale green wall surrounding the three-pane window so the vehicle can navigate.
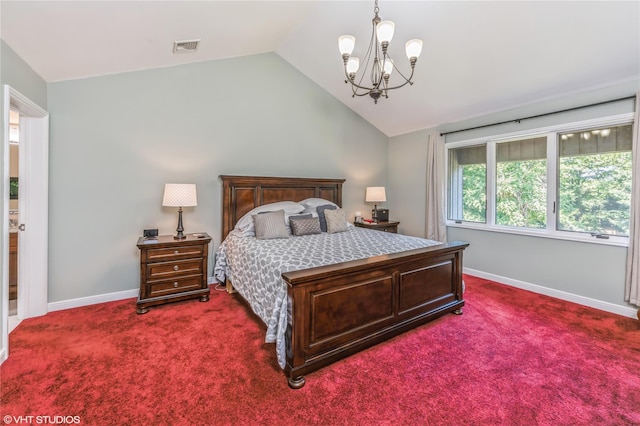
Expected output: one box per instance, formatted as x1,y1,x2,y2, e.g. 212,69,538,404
389,80,640,307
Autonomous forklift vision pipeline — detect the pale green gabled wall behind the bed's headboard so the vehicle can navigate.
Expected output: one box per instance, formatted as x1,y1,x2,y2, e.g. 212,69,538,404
48,54,388,302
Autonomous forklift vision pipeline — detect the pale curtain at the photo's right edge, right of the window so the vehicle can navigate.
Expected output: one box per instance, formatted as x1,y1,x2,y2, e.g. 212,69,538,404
625,92,640,312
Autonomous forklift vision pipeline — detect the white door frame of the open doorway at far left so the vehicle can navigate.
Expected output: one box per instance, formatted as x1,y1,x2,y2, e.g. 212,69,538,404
0,84,49,363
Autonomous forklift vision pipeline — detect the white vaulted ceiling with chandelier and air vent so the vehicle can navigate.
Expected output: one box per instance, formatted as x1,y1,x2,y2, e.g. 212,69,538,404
0,0,640,136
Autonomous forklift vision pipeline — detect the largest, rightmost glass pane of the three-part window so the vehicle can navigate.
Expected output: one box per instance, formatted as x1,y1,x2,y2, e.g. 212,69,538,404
558,125,632,236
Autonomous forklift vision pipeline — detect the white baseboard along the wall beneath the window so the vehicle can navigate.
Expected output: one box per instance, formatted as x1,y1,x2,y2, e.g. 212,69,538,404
463,268,637,319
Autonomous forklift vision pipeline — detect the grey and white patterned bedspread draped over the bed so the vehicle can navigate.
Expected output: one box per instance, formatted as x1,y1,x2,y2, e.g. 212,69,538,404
214,226,441,368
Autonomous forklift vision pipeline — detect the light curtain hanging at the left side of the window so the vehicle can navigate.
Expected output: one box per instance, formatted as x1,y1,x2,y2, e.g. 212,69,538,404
425,129,447,242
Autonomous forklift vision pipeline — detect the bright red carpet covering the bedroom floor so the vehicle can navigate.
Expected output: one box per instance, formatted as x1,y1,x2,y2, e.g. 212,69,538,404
0,276,640,425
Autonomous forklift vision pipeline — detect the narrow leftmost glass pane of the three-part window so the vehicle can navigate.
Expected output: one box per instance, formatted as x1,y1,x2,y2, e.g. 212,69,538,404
449,145,487,223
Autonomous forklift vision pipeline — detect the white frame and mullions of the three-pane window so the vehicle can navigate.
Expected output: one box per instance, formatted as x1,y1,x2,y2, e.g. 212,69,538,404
444,113,634,247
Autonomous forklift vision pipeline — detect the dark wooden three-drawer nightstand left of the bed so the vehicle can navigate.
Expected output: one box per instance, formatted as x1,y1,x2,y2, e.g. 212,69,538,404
136,233,211,314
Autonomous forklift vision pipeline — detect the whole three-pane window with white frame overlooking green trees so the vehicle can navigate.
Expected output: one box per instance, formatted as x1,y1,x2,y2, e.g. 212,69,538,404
446,114,632,245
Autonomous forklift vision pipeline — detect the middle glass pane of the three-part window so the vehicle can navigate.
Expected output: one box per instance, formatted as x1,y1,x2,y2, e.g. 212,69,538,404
496,137,547,228
